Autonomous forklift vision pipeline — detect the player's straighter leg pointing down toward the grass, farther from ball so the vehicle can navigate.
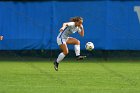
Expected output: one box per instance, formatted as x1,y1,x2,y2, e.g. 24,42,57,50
54,39,68,71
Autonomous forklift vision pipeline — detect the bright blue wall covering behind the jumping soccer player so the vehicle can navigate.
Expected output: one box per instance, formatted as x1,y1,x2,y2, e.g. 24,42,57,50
0,1,140,50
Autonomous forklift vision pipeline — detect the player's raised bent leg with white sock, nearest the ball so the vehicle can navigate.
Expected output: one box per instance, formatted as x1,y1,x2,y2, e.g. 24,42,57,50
66,37,86,60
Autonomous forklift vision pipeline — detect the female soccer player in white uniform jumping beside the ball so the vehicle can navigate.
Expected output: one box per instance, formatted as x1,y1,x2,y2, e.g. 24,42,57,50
54,17,86,71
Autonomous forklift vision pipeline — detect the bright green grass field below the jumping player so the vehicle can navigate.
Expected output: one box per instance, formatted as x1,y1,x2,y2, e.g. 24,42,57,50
0,59,140,93
